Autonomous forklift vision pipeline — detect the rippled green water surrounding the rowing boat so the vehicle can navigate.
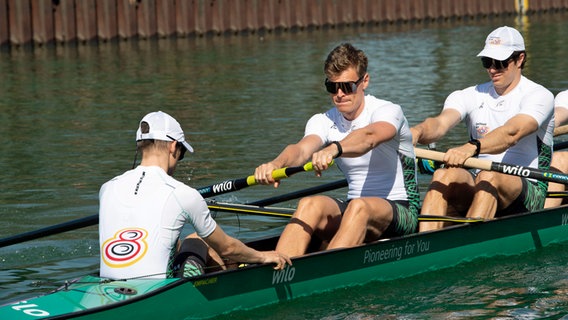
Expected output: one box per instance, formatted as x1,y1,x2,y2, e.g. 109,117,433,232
0,13,568,319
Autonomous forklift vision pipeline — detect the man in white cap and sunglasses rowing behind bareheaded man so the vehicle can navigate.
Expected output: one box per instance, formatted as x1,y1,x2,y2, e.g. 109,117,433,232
411,26,554,231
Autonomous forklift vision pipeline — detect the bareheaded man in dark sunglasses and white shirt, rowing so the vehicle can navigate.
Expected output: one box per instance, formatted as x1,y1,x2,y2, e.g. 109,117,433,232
255,43,420,257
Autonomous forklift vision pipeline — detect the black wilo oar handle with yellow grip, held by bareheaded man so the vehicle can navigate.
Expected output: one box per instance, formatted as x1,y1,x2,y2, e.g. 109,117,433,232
197,161,324,198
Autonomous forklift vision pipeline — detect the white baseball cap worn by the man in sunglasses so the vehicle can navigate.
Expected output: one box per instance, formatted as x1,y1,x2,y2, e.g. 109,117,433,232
477,26,525,61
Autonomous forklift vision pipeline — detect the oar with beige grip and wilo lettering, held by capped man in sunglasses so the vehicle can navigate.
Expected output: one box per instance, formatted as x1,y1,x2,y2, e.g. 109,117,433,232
414,148,568,184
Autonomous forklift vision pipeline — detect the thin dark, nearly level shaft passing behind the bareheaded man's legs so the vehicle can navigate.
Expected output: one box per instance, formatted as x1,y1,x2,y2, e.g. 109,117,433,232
208,201,485,223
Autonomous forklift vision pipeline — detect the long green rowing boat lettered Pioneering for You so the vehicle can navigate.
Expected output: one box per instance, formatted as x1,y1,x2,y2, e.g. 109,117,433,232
0,206,568,319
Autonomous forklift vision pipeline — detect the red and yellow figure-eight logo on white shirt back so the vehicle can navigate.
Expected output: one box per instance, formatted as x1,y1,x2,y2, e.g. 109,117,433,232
102,229,148,268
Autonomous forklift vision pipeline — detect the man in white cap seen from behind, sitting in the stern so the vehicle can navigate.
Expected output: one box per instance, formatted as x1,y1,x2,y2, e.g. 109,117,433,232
99,111,290,279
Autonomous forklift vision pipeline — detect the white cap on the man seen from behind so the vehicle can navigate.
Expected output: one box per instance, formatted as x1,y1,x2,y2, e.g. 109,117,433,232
136,111,193,152
